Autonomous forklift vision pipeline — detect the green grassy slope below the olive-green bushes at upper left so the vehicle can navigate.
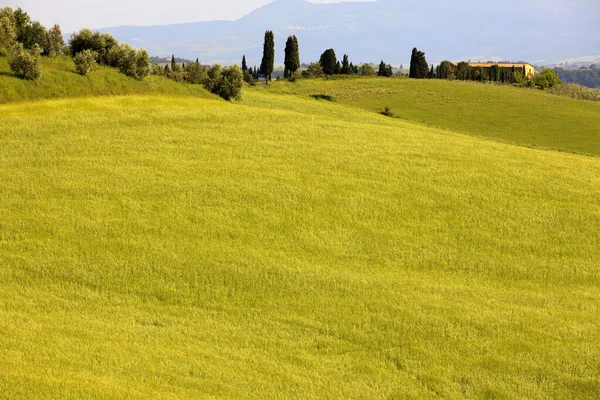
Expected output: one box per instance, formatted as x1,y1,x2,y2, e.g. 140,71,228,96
0,57,212,103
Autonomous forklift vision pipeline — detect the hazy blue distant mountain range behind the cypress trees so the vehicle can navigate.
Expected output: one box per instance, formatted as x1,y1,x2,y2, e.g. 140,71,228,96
99,0,600,65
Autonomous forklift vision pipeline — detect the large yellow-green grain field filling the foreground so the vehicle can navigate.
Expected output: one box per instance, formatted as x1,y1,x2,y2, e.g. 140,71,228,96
0,91,600,399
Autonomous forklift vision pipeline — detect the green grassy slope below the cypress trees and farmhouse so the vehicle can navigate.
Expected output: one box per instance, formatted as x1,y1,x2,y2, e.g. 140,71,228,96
257,78,600,155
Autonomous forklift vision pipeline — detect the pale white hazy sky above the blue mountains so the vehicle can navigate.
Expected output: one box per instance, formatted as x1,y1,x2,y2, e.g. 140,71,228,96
7,0,376,33
